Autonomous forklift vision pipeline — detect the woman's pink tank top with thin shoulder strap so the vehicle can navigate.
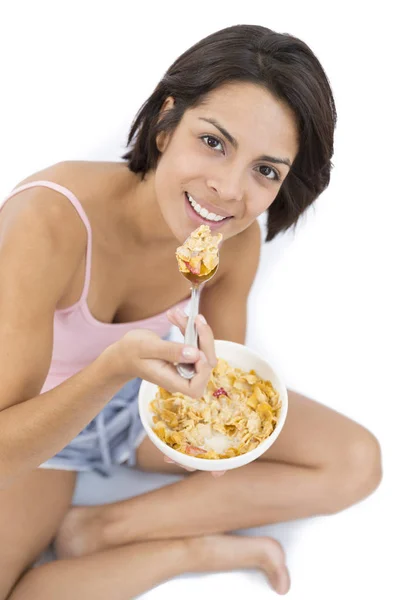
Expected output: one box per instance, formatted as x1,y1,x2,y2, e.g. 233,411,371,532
0,181,188,393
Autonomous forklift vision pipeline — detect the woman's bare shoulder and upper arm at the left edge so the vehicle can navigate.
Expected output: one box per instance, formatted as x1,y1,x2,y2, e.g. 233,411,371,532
0,168,93,411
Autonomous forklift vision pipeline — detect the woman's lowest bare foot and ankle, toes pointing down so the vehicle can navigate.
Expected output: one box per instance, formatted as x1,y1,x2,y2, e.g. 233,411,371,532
188,535,290,594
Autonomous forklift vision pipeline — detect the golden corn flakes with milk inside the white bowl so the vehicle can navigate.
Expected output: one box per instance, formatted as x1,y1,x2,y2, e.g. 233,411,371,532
150,358,281,460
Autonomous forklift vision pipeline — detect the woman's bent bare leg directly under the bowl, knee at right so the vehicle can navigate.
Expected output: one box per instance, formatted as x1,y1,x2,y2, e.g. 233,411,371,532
58,393,380,556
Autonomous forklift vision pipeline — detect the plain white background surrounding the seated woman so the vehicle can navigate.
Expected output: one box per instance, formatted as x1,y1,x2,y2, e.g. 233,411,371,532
0,0,400,600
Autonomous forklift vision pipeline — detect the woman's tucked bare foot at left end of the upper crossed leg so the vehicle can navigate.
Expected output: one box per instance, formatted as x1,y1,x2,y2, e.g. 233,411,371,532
53,506,102,558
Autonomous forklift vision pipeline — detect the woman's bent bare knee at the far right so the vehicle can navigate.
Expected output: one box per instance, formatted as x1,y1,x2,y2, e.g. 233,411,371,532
326,425,382,512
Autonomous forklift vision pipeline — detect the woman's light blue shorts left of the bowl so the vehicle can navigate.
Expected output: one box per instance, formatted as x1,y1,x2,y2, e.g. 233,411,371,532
40,378,146,477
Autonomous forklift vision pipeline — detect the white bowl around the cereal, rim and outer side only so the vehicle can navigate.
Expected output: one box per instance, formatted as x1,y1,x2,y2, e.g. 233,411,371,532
139,340,288,471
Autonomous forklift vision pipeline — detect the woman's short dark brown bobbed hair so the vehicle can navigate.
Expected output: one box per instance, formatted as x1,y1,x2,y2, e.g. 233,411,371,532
123,25,336,241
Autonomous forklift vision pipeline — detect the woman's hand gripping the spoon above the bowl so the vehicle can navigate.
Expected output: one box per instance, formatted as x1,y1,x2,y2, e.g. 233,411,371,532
106,311,217,398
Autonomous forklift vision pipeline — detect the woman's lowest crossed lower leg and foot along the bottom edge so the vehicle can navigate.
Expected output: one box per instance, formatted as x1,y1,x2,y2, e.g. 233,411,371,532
8,535,289,600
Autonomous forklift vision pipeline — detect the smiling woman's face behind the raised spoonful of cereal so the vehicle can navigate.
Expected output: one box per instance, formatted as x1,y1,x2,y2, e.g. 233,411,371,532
154,83,298,242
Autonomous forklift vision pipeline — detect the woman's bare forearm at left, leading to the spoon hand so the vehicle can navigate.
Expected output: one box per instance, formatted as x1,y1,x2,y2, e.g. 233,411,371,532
0,351,133,489
